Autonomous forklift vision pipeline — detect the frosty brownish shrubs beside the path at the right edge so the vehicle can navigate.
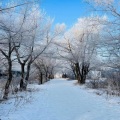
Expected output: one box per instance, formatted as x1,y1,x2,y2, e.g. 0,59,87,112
86,71,120,96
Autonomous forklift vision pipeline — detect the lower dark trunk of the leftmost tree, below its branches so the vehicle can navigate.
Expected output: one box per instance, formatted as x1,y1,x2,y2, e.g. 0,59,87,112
3,59,12,99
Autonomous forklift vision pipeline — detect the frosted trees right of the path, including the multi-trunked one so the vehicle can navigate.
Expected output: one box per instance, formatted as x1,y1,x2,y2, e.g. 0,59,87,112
55,0,120,84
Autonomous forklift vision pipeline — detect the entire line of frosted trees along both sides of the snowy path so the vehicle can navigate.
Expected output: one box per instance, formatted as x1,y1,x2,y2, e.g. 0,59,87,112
0,0,120,98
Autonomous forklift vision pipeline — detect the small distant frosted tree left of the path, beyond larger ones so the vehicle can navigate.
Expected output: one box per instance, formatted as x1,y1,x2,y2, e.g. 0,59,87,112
34,56,57,84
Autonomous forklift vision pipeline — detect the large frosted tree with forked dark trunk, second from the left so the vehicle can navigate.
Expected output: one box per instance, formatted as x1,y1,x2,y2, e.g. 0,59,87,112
14,4,65,89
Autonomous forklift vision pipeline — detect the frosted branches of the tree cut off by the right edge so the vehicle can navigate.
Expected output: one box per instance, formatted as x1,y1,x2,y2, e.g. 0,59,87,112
88,0,120,75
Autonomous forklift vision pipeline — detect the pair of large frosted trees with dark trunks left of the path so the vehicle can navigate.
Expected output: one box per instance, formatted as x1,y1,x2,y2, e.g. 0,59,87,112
0,2,63,99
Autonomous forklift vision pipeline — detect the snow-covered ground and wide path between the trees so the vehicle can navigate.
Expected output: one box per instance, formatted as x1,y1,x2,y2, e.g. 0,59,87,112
0,79,120,120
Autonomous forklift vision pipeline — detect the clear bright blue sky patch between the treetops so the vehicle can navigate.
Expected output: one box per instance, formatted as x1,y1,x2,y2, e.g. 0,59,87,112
40,0,90,27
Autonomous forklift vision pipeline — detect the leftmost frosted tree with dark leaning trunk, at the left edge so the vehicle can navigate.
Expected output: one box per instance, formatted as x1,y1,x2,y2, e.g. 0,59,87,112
0,0,39,99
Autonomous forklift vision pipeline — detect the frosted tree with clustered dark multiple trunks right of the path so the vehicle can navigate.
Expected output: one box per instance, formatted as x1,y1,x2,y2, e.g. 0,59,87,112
56,17,104,84
